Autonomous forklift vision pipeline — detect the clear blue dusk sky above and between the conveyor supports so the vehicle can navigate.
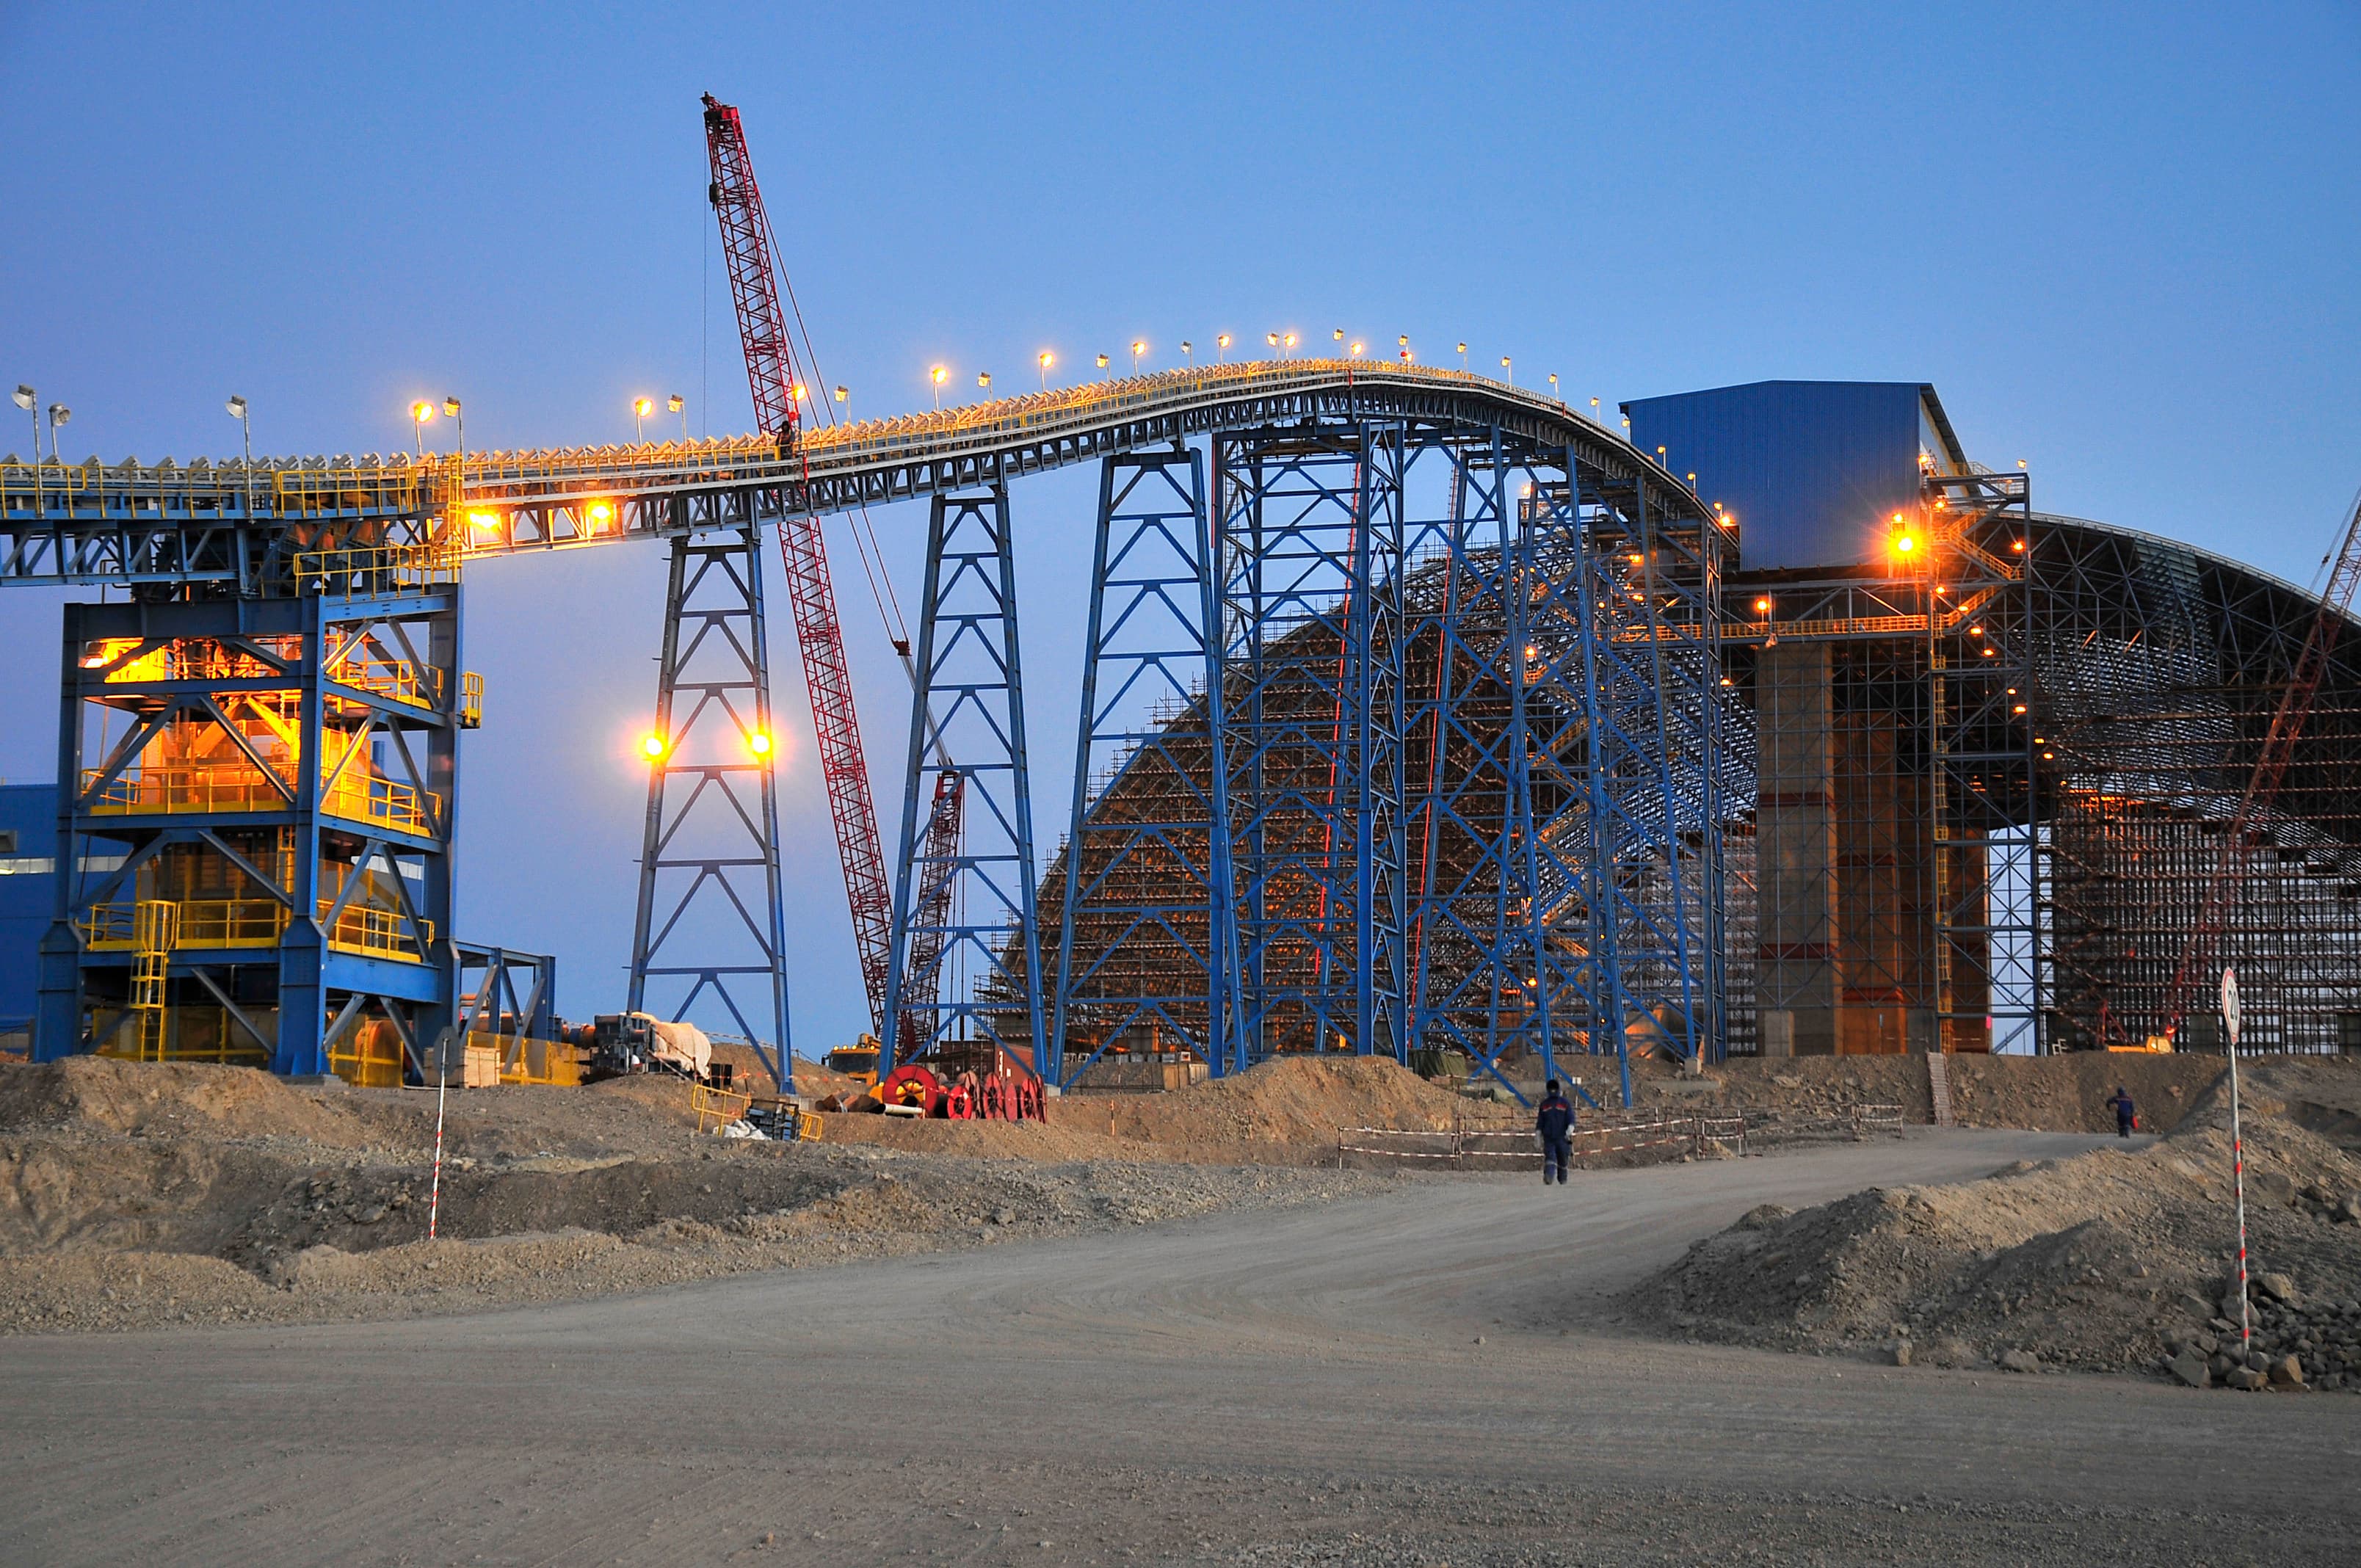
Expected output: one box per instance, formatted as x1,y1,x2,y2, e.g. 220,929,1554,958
0,0,2361,1051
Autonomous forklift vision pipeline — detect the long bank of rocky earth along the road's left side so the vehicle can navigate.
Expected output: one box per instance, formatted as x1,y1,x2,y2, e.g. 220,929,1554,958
0,1058,1424,1332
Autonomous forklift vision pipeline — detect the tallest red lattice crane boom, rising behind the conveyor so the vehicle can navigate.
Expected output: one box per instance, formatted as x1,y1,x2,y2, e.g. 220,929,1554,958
703,92,893,1039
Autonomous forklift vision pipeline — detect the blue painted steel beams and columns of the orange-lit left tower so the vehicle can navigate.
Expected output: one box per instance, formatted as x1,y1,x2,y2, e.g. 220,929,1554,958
33,588,463,1077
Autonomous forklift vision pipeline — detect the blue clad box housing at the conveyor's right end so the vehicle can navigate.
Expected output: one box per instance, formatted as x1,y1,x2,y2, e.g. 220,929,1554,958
1625,380,1945,569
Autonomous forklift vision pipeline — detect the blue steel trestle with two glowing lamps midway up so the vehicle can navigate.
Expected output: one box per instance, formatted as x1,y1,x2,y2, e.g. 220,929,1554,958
628,526,796,1093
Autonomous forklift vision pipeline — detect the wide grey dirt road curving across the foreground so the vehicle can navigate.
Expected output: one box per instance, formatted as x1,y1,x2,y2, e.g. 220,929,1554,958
0,1131,2361,1568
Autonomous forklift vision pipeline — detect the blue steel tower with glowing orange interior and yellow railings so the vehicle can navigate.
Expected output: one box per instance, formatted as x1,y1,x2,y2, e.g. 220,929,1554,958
35,576,460,1081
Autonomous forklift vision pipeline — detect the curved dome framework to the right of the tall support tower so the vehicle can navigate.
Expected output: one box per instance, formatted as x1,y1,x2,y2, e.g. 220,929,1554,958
2031,515,2361,1051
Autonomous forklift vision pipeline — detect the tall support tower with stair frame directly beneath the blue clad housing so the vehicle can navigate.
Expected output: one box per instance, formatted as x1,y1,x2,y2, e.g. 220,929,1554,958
1724,472,2045,1056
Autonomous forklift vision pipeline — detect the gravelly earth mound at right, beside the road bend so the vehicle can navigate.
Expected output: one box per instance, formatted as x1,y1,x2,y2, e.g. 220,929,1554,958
1631,1060,2361,1389
